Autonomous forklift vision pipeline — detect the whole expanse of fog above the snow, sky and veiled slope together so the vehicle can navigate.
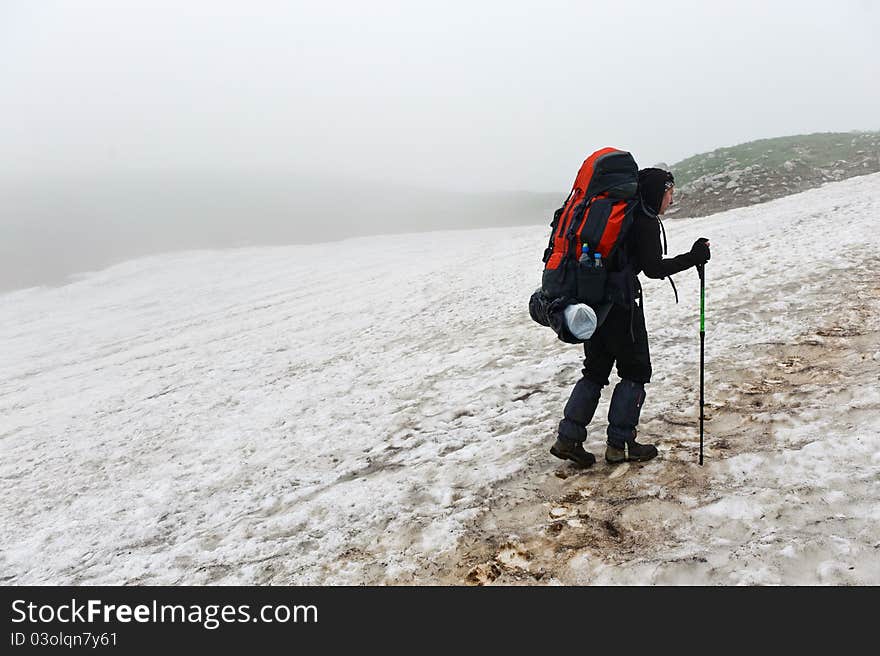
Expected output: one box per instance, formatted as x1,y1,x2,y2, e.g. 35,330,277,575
0,0,880,289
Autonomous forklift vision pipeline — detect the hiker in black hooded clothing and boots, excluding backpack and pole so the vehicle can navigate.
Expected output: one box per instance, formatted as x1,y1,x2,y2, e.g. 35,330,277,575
550,168,710,467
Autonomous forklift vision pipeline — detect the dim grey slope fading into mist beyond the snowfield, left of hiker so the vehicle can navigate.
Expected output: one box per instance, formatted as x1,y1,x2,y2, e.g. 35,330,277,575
0,173,559,290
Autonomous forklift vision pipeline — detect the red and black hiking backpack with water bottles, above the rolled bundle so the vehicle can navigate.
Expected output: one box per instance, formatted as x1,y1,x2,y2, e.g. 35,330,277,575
541,148,639,309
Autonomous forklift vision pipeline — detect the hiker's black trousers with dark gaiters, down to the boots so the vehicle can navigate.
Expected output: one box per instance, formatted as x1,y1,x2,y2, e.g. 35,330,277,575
559,303,651,446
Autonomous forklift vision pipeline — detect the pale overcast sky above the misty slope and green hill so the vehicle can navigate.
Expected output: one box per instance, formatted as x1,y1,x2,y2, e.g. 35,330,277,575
0,0,880,191
